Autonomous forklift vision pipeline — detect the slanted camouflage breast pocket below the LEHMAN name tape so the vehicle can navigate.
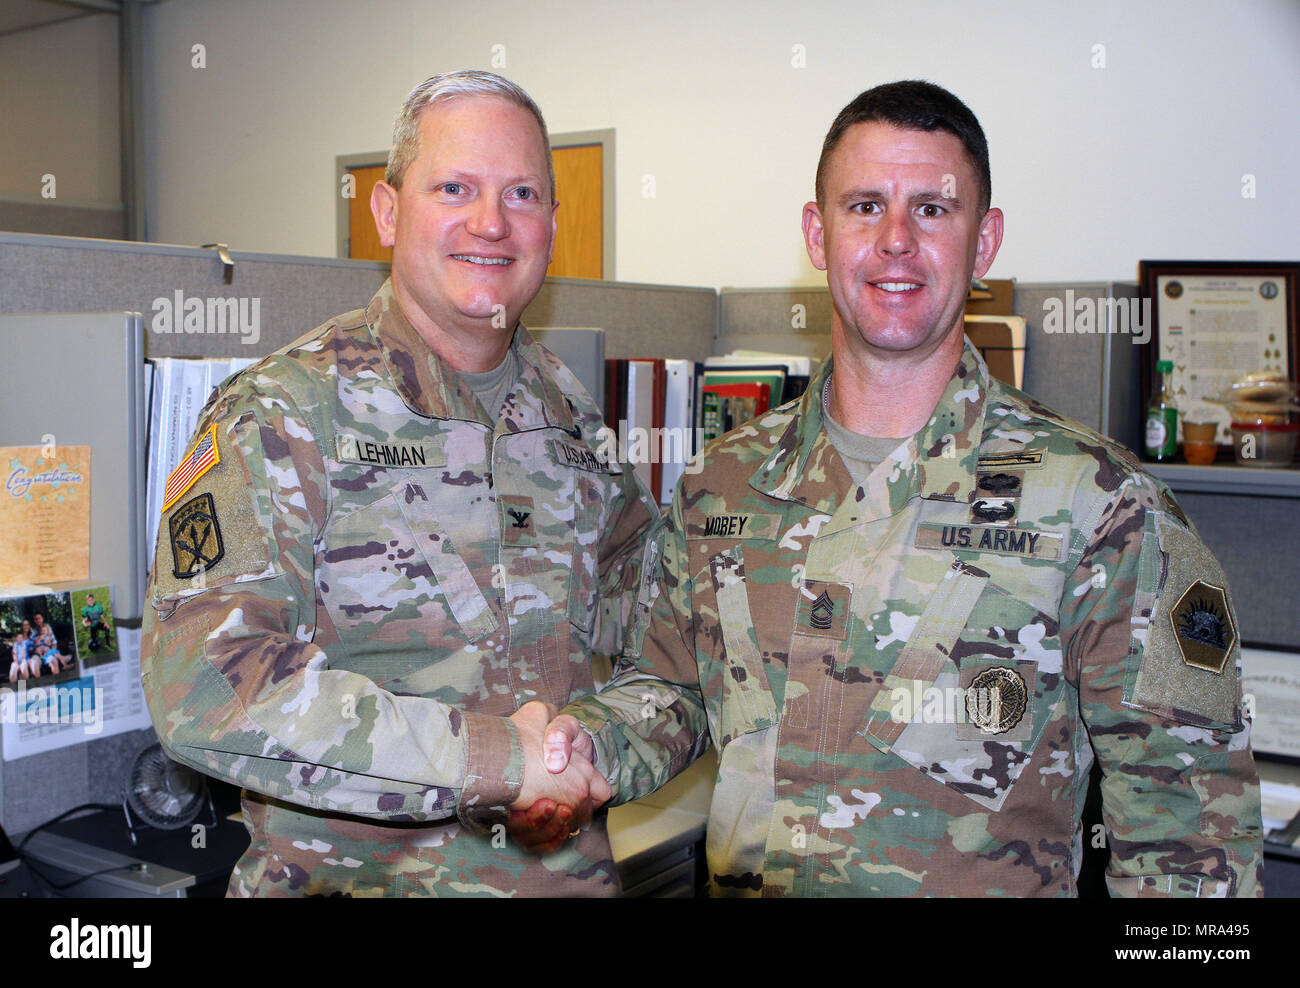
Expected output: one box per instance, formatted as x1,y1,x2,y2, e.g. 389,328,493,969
317,482,497,685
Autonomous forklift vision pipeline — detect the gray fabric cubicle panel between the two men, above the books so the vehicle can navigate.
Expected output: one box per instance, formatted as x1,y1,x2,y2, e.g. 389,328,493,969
523,278,718,360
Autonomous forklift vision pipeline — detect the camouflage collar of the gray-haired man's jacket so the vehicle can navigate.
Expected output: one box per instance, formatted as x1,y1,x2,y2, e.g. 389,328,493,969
365,278,573,432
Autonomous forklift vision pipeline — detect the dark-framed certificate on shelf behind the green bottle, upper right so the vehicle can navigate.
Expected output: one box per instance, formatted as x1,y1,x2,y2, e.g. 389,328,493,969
1138,261,1300,443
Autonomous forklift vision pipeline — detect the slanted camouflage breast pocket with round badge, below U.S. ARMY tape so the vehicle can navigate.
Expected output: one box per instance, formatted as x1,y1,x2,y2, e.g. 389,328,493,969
866,567,1063,810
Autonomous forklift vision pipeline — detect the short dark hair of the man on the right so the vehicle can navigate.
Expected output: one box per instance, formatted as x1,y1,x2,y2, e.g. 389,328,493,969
816,79,993,216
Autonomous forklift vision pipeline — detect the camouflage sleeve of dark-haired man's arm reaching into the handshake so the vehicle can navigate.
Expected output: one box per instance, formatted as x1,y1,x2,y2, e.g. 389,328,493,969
562,488,709,803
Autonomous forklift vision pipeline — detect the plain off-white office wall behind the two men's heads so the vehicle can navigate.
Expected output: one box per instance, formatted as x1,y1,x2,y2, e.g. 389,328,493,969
0,0,1300,287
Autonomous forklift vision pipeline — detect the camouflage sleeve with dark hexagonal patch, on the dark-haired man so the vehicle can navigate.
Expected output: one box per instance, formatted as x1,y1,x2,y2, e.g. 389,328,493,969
1061,475,1262,897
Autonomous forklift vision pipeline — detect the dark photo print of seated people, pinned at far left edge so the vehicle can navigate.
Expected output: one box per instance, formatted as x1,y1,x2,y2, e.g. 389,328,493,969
0,593,78,686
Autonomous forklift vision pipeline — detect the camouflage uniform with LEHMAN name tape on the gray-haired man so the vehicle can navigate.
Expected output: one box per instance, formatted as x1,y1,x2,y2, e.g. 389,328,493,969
142,283,658,896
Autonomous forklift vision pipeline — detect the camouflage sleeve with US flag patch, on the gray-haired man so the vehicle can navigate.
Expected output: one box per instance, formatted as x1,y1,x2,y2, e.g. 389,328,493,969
140,374,523,827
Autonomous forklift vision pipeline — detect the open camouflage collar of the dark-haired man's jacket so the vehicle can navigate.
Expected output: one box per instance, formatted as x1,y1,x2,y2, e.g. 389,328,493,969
750,339,989,514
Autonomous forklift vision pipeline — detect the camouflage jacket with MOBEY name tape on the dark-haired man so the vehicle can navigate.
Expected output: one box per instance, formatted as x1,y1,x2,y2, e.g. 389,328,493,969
568,343,1261,896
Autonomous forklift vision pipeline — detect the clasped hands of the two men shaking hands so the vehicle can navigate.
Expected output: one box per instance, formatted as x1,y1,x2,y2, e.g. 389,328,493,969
506,701,614,854
